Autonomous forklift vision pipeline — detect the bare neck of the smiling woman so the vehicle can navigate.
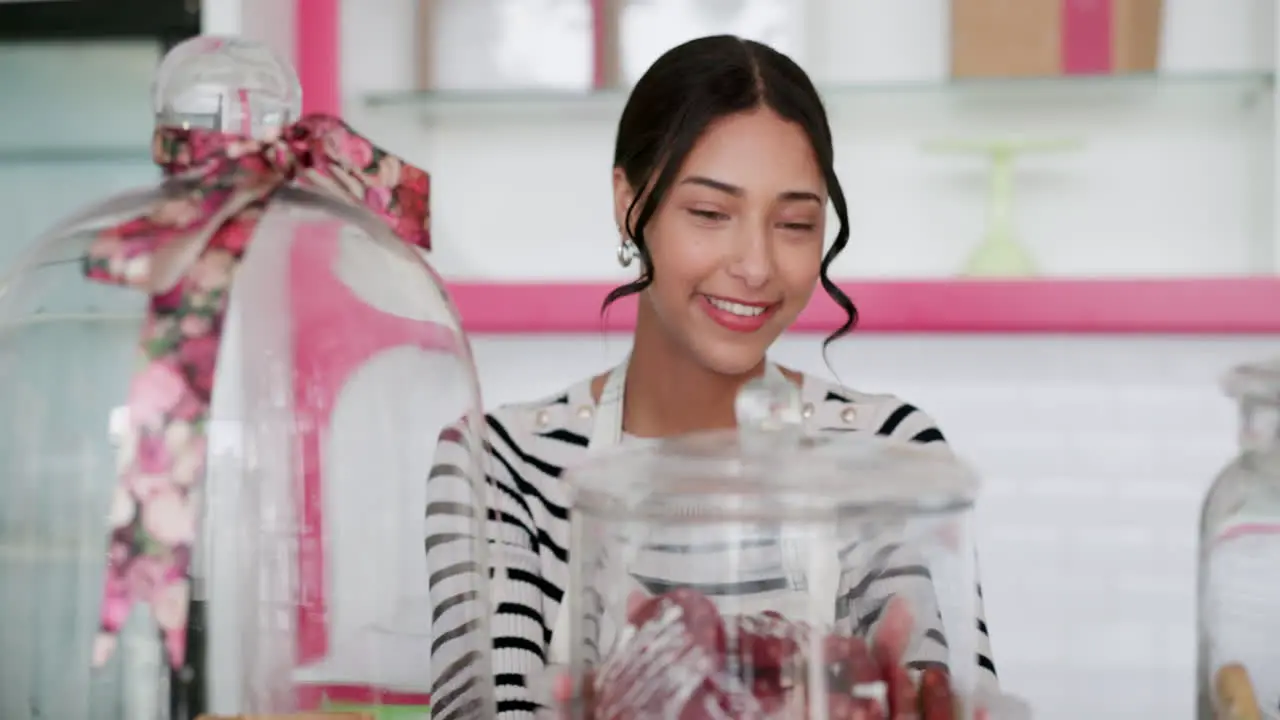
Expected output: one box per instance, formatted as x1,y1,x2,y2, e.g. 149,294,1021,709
622,300,764,437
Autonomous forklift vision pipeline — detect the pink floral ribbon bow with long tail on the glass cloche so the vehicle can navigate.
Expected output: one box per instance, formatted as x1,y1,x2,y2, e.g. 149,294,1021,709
84,115,430,667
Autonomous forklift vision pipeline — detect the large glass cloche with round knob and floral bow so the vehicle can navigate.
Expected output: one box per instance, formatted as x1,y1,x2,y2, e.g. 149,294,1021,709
0,37,493,720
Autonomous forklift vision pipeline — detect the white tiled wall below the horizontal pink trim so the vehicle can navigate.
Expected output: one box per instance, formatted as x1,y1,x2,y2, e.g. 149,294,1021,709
474,336,1280,720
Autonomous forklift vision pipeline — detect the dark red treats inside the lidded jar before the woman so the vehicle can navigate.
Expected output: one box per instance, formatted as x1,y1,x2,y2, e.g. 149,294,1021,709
593,589,956,720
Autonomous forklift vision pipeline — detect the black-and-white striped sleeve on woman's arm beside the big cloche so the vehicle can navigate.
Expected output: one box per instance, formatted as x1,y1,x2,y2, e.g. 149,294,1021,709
426,416,549,720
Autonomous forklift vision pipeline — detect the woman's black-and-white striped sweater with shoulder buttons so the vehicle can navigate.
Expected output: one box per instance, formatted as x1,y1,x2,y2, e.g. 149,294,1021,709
426,375,996,720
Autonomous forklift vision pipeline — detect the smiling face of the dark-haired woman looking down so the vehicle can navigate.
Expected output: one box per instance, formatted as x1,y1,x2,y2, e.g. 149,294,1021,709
614,108,827,375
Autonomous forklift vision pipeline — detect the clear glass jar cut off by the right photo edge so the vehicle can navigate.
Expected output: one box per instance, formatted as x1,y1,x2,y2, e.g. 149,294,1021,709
1197,360,1280,720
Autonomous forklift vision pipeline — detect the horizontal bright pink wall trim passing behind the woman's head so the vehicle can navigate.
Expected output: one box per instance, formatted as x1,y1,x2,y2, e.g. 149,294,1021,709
449,278,1280,334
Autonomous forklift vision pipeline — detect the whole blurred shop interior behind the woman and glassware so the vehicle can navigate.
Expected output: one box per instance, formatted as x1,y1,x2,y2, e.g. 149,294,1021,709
0,0,1280,720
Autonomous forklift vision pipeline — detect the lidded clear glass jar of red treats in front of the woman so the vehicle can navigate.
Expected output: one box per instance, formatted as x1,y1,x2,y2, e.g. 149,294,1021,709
557,378,1027,720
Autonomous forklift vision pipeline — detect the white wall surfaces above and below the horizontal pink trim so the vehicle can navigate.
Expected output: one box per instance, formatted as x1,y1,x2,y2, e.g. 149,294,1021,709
332,0,1280,720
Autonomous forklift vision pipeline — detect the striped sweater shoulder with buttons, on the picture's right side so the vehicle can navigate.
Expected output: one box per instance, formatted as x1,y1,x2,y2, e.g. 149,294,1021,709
804,374,946,447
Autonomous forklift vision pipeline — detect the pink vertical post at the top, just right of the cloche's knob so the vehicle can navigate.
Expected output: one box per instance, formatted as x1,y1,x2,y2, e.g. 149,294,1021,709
293,0,342,115
